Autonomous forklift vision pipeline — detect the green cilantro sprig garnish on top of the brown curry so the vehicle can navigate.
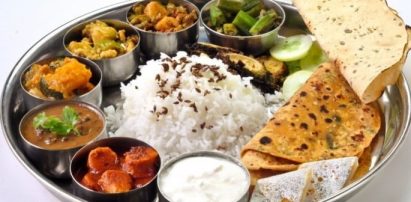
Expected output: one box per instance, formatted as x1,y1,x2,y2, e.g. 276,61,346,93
33,106,80,136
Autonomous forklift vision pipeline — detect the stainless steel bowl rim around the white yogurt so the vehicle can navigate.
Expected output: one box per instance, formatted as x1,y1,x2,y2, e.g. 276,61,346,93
157,151,251,202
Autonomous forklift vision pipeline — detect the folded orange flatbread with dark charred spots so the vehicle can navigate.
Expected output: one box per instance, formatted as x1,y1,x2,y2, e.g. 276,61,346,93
241,63,381,164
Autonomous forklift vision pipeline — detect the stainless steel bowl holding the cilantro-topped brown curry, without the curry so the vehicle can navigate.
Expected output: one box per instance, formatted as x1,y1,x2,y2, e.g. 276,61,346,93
19,100,107,178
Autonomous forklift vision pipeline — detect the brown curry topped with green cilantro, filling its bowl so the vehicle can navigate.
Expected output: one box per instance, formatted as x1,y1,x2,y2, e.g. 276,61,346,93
20,102,105,150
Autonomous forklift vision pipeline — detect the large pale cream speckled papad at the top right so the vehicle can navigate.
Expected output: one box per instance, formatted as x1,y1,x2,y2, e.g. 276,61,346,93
293,0,409,103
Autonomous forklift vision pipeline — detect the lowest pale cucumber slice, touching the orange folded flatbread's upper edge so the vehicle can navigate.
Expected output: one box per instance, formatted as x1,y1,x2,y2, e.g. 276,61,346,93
282,70,313,101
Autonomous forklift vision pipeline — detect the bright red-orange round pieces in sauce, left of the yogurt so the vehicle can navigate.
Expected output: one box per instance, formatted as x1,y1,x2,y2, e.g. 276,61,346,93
80,146,159,193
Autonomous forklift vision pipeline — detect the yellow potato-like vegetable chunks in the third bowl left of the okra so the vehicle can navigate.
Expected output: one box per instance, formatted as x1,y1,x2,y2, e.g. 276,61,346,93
67,20,138,60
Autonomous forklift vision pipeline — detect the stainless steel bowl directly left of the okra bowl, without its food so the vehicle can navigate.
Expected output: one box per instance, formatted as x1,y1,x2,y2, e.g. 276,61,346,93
127,0,200,58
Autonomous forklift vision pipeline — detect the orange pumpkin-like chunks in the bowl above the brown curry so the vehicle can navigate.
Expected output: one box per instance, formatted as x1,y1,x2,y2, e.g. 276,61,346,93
23,57,94,100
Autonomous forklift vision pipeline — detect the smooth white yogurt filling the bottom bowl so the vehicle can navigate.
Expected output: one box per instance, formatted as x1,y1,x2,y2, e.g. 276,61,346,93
159,156,249,202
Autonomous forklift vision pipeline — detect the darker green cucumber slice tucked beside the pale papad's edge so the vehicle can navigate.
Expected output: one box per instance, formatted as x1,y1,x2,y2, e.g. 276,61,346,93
300,42,328,72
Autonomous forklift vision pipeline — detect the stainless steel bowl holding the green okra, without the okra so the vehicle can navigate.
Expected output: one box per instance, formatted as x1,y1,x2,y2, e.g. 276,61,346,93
200,0,286,55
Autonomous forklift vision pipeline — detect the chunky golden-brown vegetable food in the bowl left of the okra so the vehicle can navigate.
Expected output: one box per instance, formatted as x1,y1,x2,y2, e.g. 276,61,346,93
128,1,198,32
